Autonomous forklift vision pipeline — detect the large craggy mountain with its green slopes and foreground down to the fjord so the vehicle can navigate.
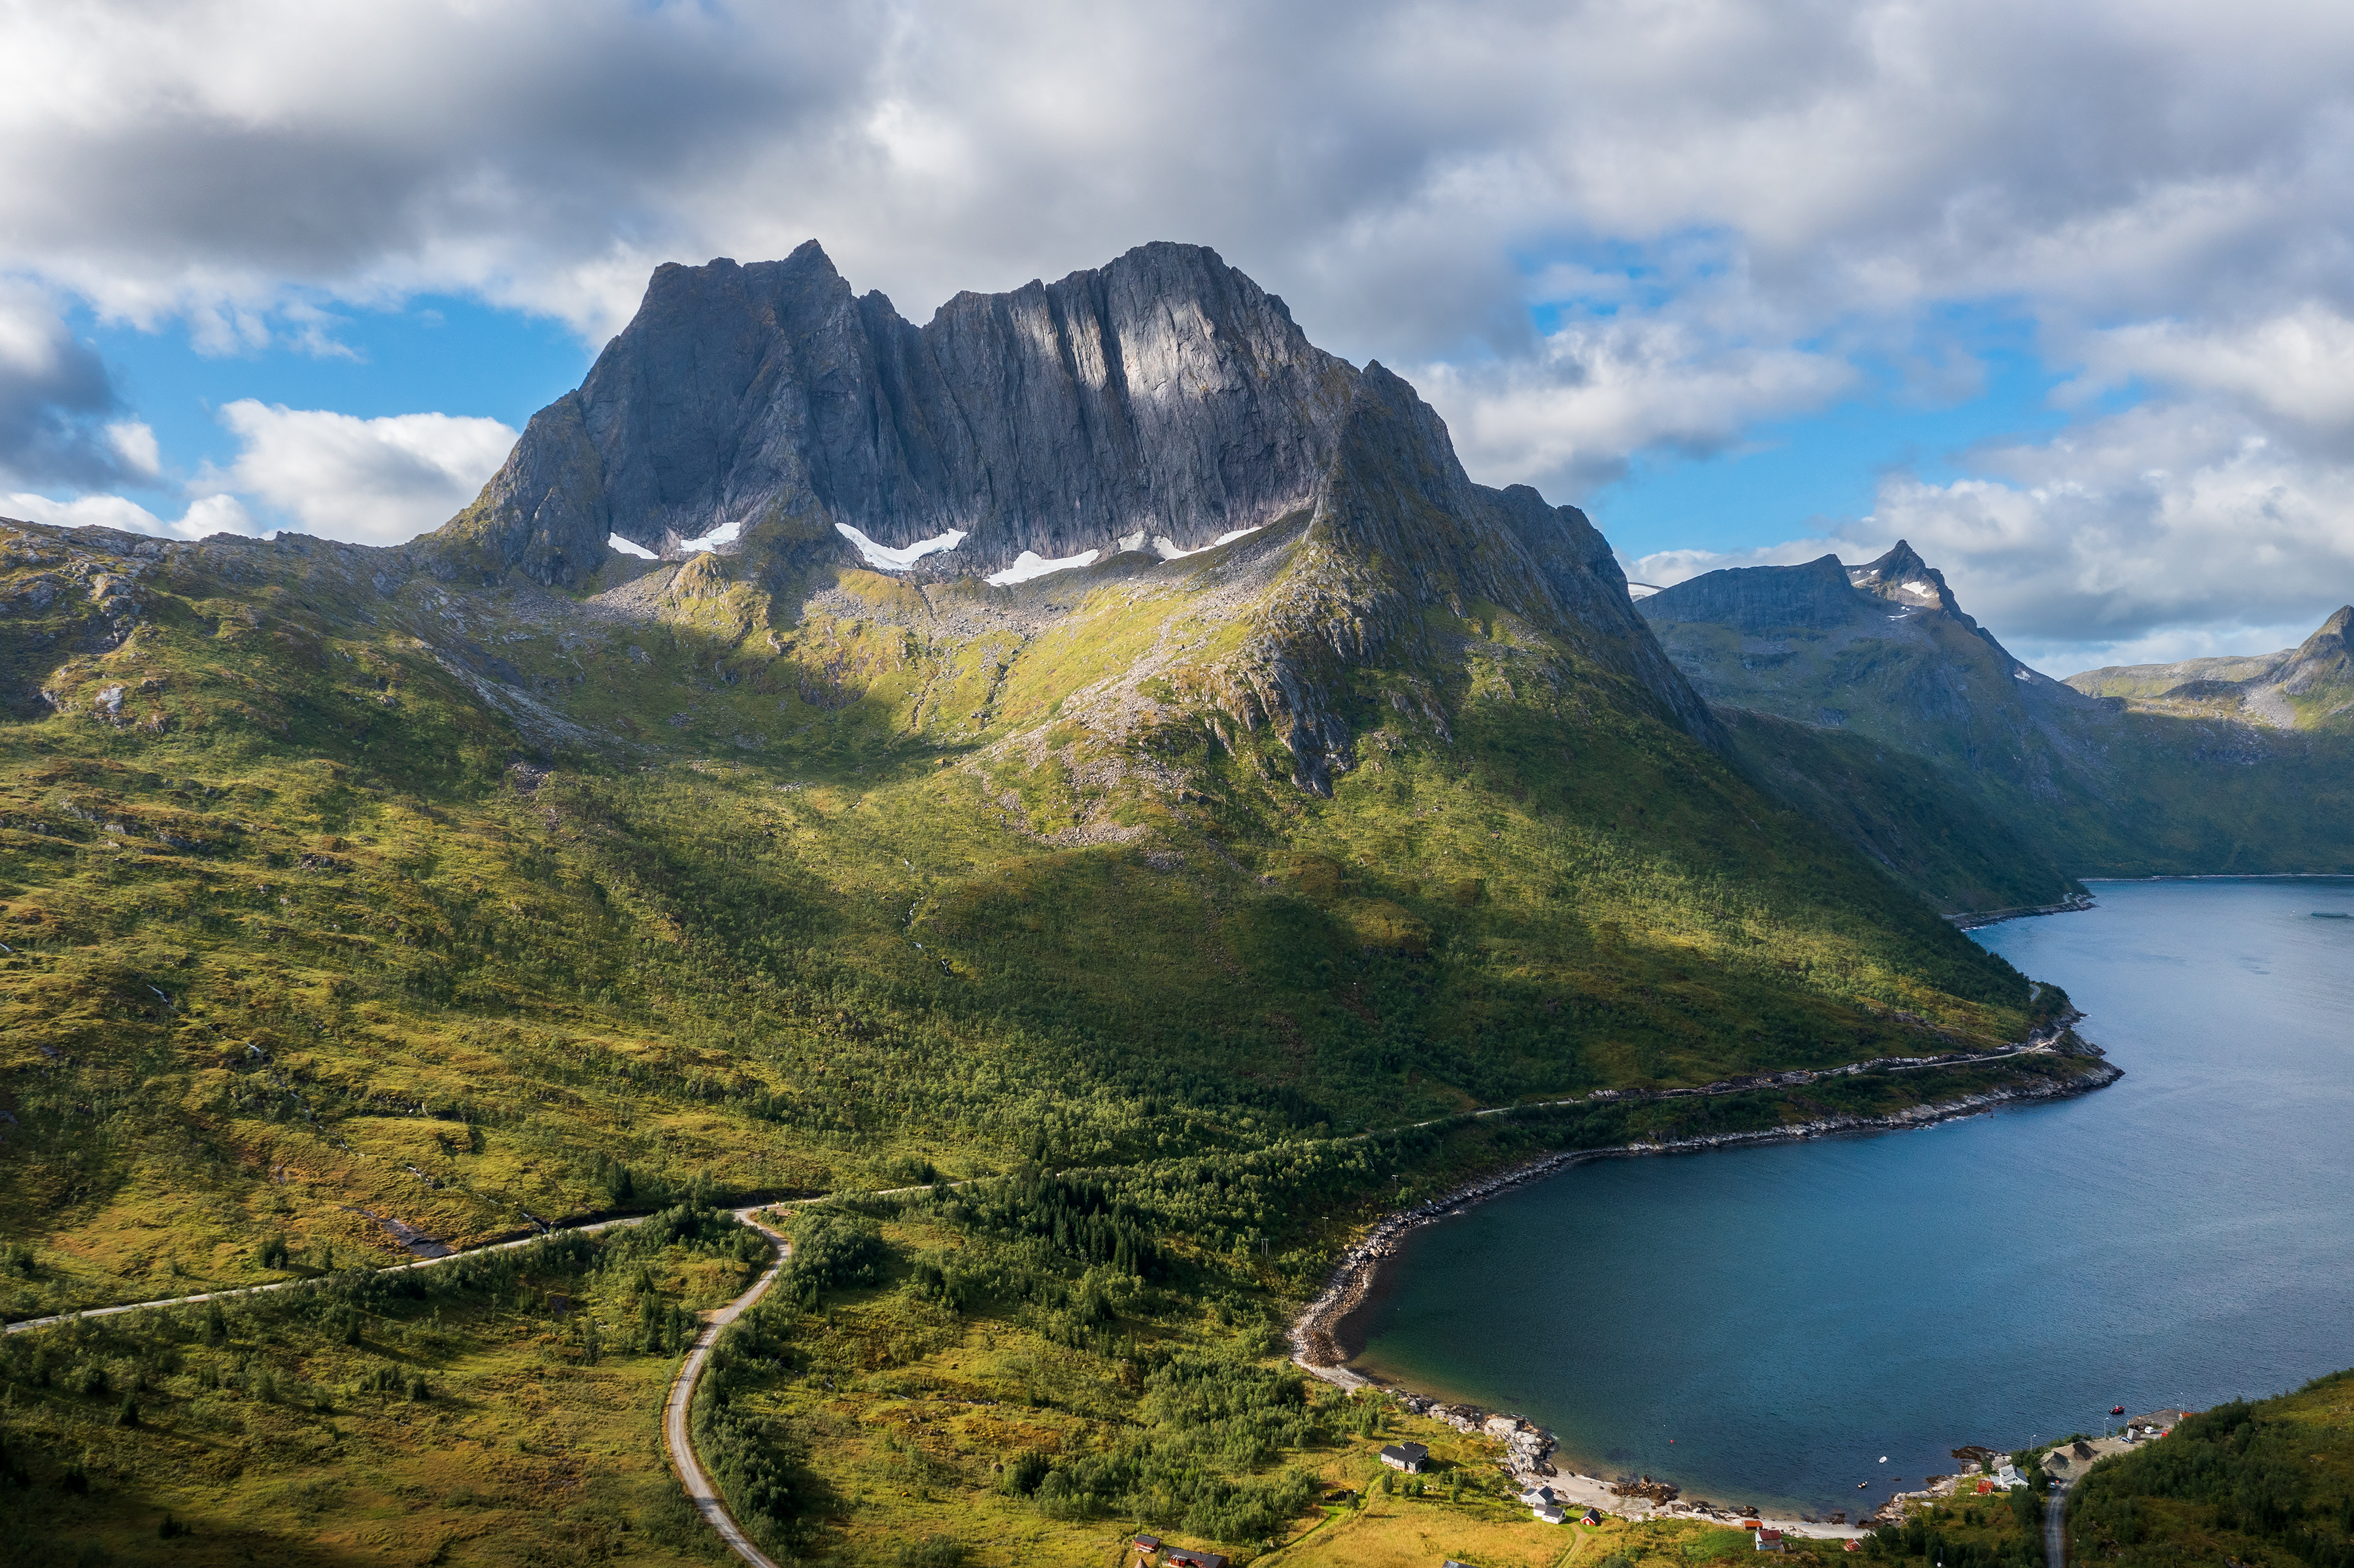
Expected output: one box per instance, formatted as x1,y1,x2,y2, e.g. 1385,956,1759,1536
0,245,2107,1561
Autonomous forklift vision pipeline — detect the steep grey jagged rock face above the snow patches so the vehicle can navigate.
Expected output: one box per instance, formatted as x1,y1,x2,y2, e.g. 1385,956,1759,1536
447,240,1358,581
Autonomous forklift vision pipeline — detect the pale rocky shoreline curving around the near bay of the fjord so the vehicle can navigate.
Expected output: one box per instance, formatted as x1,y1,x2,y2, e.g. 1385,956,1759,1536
1290,1026,2126,1537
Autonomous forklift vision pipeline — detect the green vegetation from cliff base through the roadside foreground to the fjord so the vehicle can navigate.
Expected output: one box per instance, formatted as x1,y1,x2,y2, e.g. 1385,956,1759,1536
0,506,2081,1563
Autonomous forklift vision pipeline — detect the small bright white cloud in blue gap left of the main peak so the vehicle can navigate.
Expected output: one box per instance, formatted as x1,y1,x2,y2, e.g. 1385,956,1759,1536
203,398,515,544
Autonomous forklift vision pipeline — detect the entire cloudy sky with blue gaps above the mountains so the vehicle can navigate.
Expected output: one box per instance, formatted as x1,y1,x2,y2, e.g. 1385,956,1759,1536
0,0,2354,673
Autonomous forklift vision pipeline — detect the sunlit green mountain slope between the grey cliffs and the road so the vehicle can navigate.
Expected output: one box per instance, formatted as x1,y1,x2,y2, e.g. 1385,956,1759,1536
0,515,2100,1556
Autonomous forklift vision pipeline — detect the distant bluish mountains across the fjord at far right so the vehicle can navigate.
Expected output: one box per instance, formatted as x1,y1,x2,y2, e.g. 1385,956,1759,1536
1639,541,2354,885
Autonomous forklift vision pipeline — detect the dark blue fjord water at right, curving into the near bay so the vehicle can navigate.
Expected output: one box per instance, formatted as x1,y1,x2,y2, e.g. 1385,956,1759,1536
1356,878,2354,1512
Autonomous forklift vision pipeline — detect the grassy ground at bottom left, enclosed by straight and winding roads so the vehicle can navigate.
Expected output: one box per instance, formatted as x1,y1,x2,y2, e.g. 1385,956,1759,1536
0,1208,768,1563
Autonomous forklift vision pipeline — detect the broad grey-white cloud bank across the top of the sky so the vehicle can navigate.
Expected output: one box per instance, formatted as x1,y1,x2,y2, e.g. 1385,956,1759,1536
0,0,2354,358
